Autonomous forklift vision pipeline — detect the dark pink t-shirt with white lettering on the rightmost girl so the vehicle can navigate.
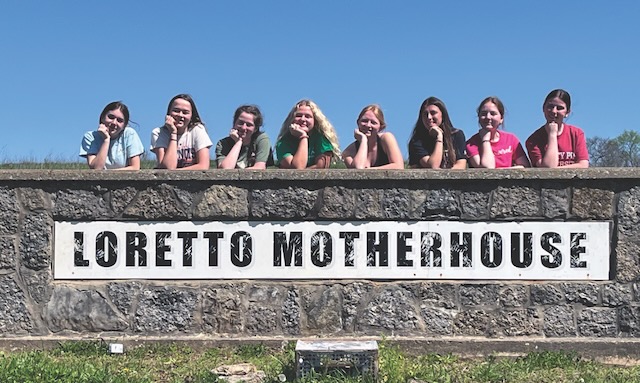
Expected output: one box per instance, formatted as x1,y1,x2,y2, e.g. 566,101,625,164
526,124,589,166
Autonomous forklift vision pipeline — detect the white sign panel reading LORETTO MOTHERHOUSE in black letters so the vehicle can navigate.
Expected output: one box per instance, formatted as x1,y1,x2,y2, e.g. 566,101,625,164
53,221,610,280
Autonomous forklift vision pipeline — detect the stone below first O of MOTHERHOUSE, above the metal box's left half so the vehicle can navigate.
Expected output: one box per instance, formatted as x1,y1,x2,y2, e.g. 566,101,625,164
300,285,343,334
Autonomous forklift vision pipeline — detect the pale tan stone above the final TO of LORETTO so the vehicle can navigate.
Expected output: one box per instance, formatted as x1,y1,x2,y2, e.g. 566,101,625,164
193,185,249,219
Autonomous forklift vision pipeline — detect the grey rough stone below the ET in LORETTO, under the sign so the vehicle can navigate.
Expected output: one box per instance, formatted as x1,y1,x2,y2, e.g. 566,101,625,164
134,287,198,334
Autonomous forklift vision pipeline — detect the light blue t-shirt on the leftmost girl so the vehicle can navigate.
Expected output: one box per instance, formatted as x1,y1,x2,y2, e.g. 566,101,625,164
80,126,144,169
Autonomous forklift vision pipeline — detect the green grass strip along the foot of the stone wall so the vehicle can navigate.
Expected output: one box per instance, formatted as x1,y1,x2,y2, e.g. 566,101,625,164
0,341,640,383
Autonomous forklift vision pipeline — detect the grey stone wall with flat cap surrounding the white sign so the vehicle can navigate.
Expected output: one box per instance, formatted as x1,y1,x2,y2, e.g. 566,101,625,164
0,169,640,352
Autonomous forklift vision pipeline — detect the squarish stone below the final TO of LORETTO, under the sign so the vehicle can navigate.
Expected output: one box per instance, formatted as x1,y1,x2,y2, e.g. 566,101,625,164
202,284,246,334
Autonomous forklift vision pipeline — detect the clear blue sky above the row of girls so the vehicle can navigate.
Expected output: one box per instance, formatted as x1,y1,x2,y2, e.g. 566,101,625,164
0,0,640,161
